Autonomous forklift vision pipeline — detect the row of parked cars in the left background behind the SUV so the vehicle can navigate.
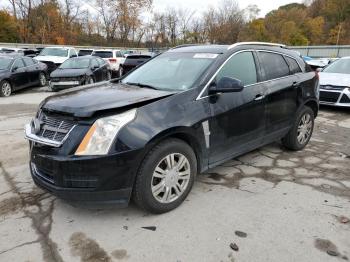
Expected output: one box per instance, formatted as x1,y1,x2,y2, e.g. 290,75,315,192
0,46,152,96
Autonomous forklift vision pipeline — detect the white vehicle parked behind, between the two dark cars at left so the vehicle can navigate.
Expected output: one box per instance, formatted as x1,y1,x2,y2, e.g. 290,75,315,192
35,46,78,74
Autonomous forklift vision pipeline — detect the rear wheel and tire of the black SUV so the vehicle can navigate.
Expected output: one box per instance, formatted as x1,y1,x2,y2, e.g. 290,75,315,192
282,106,315,151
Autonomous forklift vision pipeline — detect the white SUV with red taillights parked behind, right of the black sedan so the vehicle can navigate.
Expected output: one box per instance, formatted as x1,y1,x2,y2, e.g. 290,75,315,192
91,49,125,77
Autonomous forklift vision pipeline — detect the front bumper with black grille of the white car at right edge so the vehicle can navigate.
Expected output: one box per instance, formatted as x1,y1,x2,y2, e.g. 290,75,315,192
320,88,350,107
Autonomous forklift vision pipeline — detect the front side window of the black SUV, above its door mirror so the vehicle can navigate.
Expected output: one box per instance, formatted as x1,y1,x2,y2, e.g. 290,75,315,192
216,52,257,85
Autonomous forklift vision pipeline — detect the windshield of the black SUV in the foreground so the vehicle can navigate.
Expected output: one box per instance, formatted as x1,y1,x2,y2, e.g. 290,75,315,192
122,52,218,91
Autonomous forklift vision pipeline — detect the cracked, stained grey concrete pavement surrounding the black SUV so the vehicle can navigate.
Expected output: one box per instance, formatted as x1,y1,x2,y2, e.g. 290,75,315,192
0,88,350,262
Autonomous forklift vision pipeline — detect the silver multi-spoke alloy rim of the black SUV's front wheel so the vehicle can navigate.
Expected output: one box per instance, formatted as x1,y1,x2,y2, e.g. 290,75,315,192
151,153,191,204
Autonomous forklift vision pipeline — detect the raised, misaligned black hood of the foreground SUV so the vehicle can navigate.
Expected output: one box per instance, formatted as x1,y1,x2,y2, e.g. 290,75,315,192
41,82,174,117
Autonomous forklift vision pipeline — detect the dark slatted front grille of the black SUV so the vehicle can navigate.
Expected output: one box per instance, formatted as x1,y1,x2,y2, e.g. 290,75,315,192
37,112,74,142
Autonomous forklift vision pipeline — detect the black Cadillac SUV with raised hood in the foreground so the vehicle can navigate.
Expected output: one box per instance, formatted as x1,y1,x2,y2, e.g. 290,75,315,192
25,43,319,213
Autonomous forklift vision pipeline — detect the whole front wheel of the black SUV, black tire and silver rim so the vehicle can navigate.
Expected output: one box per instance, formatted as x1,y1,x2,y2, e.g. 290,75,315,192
133,139,197,214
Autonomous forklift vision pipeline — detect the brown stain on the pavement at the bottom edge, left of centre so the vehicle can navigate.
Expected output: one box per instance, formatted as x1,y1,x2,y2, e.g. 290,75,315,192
69,232,112,262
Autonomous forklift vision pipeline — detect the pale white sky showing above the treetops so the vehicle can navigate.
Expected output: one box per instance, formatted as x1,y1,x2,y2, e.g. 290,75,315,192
153,0,302,17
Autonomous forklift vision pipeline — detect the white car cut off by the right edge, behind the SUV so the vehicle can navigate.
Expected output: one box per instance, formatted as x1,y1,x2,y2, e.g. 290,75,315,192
319,57,350,107
